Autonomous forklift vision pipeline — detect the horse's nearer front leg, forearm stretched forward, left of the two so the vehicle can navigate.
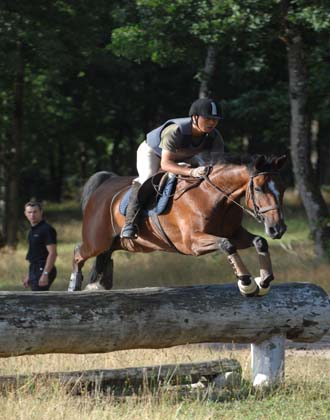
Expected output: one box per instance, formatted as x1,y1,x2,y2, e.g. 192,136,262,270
191,233,259,297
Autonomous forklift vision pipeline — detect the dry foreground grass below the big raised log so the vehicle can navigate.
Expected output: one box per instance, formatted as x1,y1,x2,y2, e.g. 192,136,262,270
0,345,330,420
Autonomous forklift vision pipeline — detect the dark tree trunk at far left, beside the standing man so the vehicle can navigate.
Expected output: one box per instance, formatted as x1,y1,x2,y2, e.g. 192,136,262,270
5,41,24,248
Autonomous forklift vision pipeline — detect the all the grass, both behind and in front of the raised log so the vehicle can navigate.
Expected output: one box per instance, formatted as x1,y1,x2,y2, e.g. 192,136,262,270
0,193,330,420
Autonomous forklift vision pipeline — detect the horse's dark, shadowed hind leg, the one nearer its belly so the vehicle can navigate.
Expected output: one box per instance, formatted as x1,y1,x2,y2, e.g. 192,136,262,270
86,251,113,290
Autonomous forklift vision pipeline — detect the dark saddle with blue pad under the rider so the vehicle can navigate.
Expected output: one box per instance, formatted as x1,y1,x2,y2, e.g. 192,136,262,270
119,172,177,216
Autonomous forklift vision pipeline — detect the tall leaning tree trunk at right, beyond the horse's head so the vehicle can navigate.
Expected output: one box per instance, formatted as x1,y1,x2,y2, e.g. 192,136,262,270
287,27,330,259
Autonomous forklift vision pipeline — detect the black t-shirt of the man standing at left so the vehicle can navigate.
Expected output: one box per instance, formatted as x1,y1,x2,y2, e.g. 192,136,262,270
26,220,57,263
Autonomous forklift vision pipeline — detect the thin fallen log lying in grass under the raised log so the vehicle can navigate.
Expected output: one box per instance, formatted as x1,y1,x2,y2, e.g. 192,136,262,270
0,359,242,393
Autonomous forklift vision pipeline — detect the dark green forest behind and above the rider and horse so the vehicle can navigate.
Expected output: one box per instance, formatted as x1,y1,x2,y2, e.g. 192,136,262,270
0,0,330,260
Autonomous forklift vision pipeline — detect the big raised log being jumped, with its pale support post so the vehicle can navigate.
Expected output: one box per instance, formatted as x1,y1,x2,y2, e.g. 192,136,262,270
0,283,330,386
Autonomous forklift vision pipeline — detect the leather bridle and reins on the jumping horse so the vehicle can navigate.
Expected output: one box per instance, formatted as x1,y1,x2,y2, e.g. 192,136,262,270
203,166,279,223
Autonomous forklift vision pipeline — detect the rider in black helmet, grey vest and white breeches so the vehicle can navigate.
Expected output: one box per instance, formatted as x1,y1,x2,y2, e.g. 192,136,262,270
120,98,224,239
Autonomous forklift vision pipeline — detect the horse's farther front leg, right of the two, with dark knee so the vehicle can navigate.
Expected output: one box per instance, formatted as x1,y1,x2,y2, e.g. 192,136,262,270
233,227,274,296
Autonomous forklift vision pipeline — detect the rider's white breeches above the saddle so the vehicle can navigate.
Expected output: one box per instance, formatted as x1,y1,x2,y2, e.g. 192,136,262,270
134,141,160,184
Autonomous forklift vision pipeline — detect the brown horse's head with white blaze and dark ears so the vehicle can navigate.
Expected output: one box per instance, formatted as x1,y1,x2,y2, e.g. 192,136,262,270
246,156,286,239
